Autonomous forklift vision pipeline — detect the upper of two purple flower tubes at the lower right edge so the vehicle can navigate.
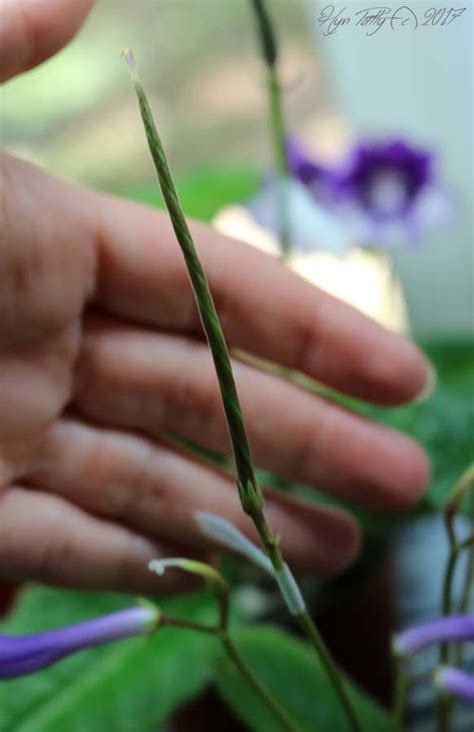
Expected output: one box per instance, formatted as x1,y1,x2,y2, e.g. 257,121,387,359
394,615,474,656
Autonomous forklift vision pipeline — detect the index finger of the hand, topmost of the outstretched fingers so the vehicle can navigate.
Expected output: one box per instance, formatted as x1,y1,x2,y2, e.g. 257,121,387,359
97,189,432,405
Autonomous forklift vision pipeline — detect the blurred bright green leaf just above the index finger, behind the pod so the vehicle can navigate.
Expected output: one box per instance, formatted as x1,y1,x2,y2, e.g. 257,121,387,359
112,167,260,221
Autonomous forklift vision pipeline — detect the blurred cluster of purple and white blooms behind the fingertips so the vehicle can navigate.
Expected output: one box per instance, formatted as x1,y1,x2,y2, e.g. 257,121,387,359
249,137,452,254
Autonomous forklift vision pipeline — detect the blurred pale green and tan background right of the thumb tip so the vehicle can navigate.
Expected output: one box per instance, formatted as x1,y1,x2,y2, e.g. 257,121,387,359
2,0,342,190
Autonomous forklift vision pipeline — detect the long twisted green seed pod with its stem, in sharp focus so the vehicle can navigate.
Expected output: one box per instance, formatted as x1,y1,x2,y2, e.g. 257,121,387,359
124,51,362,732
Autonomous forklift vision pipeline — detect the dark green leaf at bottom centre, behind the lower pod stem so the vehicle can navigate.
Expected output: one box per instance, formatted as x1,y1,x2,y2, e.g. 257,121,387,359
216,626,394,732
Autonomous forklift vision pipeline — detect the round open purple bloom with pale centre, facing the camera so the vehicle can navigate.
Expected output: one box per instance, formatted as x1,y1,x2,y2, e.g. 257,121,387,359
335,139,450,248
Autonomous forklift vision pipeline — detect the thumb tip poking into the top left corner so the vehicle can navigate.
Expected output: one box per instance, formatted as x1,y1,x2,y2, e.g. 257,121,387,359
0,0,94,82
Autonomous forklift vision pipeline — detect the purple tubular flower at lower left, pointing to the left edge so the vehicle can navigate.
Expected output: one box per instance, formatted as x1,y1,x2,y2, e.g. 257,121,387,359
0,604,160,679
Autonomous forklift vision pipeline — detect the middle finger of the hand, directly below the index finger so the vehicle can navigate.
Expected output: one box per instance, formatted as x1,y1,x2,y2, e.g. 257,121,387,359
75,316,428,510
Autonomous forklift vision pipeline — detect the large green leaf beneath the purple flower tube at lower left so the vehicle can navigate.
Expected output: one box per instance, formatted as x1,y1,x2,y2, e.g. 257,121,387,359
0,588,218,732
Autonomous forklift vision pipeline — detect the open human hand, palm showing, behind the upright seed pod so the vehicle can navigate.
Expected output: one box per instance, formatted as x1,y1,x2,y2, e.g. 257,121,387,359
0,0,430,592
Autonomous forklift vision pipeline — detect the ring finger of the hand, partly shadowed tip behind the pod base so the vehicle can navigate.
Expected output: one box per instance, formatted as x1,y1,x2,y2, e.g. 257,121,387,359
25,419,358,574
